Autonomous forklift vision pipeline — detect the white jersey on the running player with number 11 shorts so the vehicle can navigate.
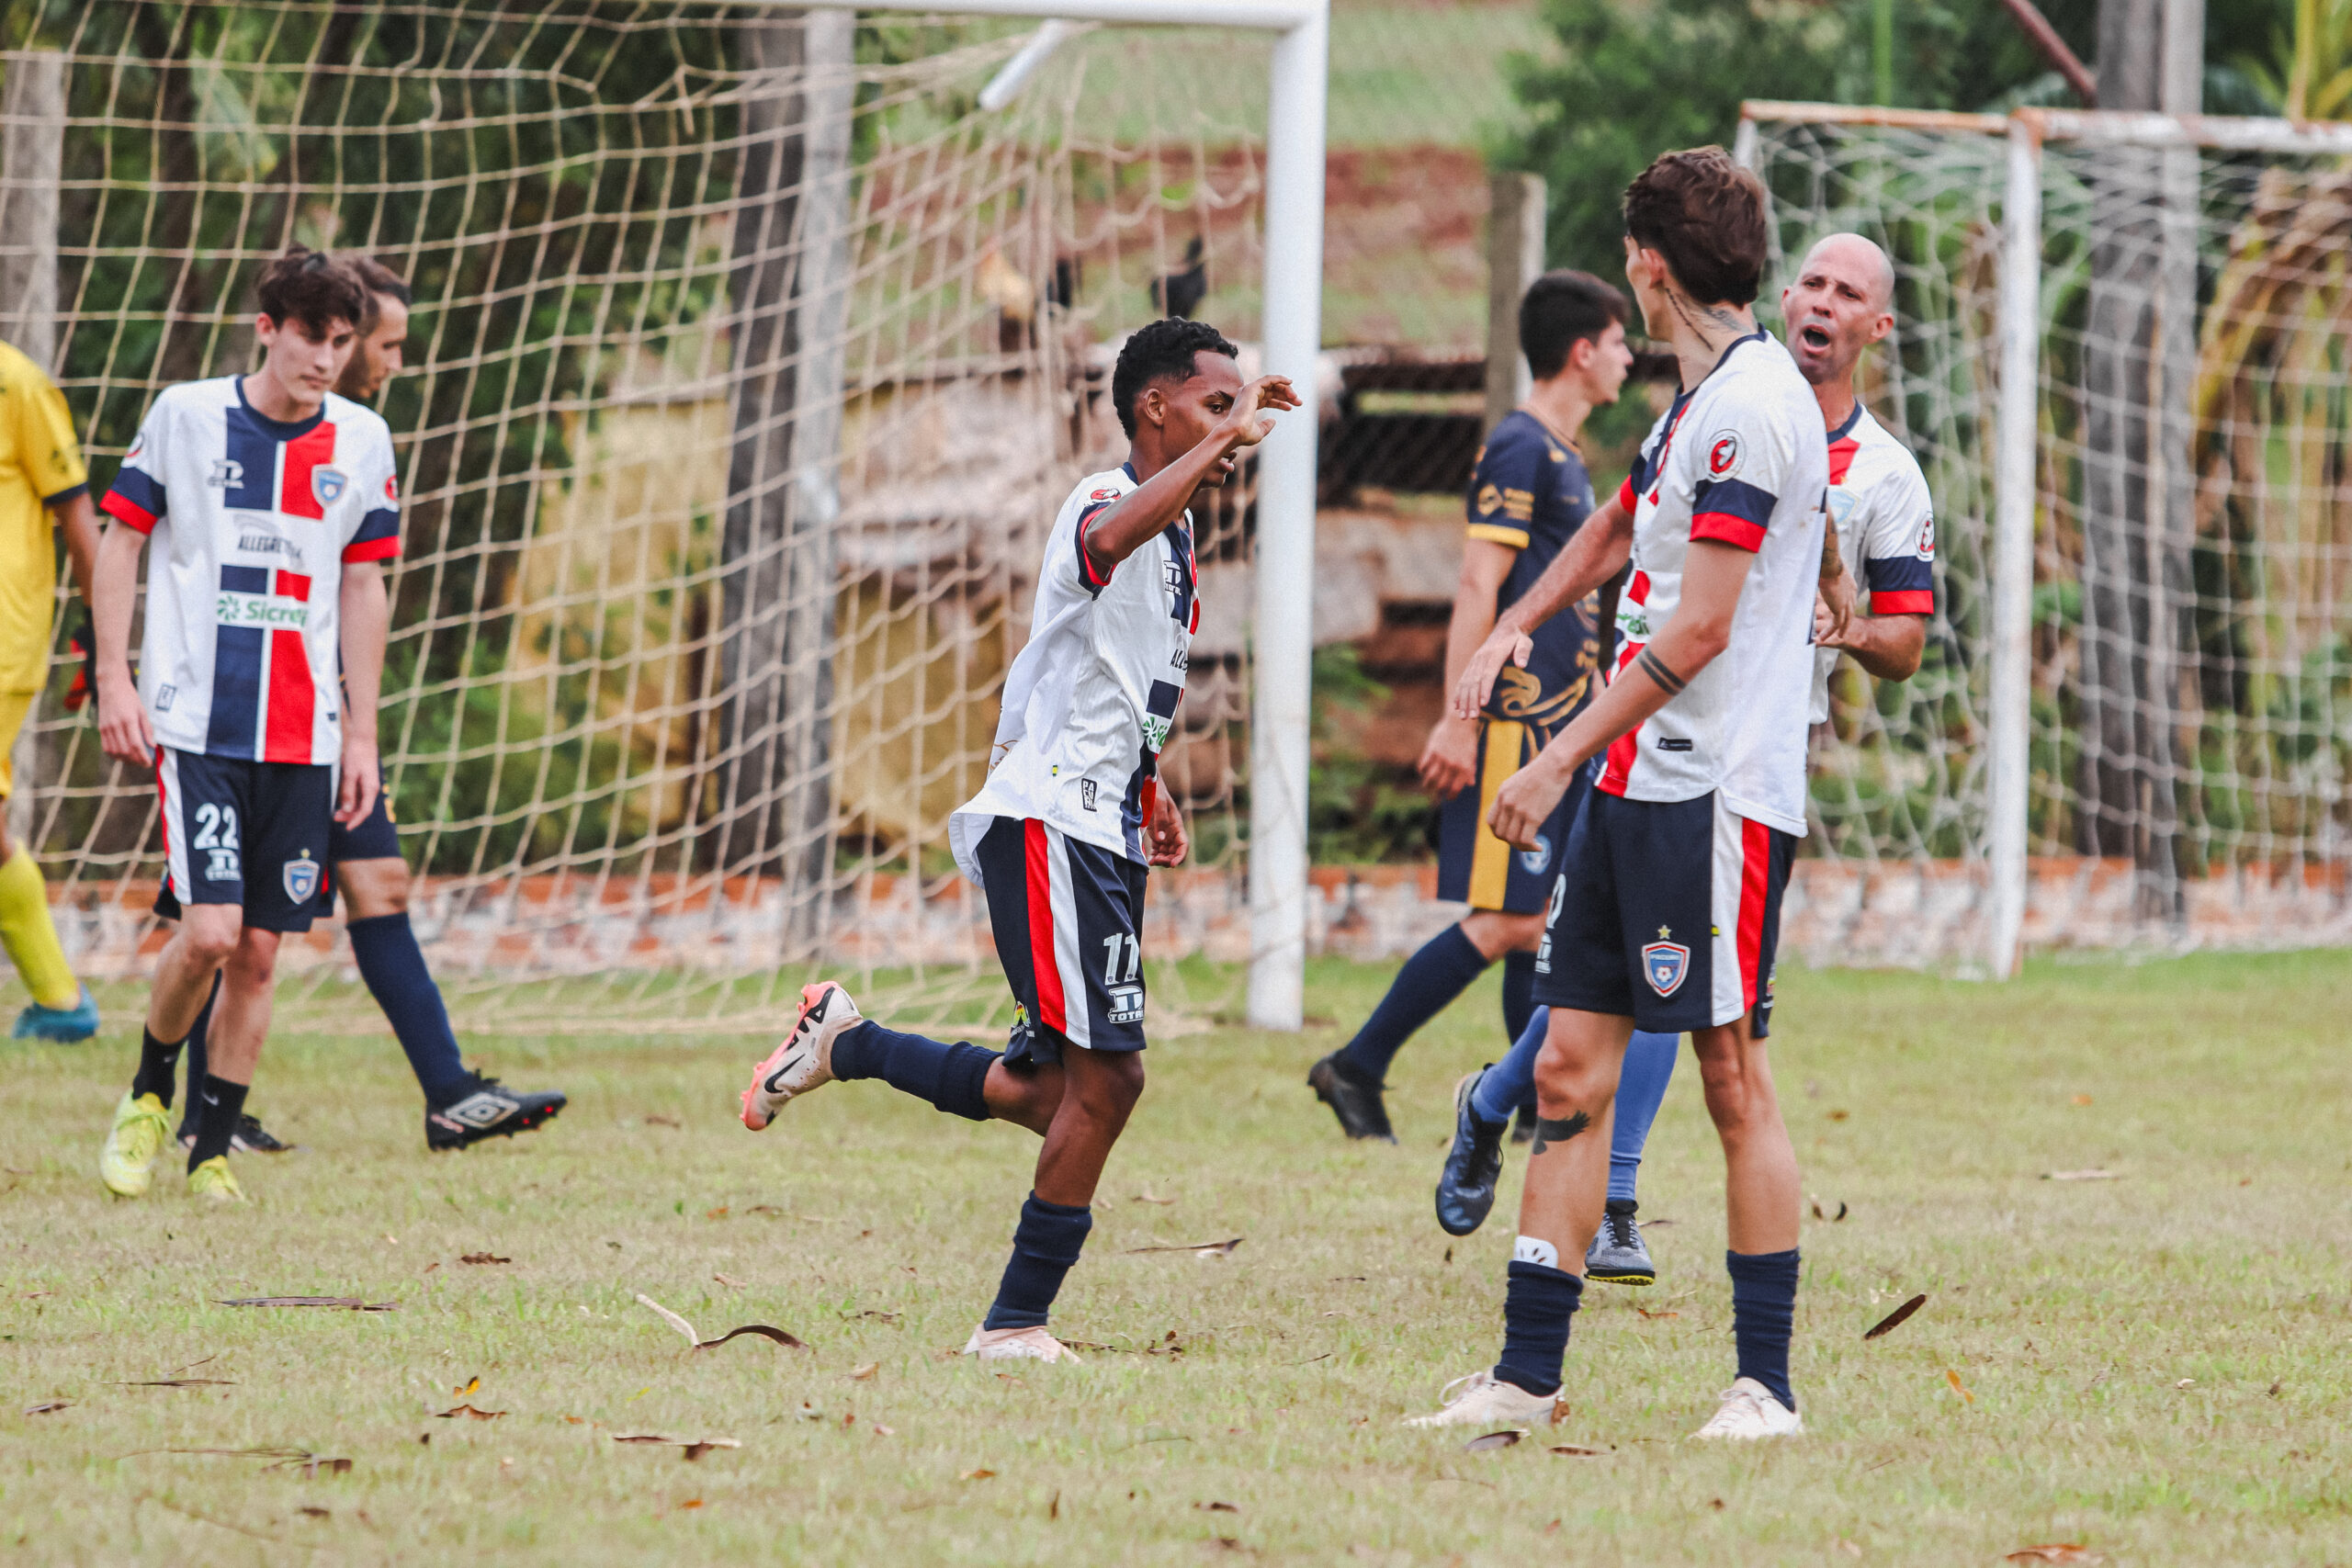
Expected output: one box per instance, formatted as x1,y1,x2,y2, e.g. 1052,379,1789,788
948,463,1200,884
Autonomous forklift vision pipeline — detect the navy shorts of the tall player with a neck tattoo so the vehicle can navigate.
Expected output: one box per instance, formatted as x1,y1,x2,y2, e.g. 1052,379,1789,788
1536,790,1797,1039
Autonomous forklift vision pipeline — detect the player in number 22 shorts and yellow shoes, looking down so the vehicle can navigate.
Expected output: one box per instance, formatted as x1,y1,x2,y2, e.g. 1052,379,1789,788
94,247,400,1199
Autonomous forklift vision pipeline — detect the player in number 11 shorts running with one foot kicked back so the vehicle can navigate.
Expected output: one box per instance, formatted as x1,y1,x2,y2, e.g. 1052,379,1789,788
743,317,1298,1361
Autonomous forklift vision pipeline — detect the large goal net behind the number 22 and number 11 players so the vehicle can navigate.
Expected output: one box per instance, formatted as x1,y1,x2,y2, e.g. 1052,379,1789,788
0,0,1272,1030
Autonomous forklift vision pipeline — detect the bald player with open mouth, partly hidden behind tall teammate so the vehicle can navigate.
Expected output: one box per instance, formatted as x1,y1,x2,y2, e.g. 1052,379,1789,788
1437,235,1936,1286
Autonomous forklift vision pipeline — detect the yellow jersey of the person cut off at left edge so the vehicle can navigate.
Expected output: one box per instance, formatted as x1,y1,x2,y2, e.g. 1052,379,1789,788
0,344,89,694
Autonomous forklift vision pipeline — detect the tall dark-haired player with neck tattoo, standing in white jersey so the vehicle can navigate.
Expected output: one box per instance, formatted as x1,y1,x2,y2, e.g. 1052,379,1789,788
1416,148,1827,1437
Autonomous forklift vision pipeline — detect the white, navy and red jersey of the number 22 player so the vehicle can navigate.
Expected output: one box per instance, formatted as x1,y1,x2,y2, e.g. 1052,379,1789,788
104,376,400,764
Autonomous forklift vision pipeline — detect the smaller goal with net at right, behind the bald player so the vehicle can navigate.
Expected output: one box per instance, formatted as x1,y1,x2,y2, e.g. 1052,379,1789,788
1740,104,2352,968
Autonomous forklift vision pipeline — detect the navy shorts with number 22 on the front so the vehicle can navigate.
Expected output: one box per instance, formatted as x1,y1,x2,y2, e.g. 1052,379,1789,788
155,745,334,931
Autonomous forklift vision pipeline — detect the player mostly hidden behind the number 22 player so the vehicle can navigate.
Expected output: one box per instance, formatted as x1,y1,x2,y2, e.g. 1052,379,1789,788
179,256,564,1155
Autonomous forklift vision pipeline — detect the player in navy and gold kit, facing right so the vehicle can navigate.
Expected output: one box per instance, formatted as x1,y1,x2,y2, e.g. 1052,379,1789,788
1307,273,1633,1143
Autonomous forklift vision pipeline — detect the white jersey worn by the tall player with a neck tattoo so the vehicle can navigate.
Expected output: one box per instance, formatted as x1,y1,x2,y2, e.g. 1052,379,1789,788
1600,332,1830,835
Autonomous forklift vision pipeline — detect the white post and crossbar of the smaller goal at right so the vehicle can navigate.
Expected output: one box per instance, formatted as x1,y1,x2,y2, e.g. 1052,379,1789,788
1734,101,2352,976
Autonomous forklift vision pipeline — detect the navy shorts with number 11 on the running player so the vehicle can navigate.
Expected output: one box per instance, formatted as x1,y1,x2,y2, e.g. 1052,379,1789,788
974,816,1143,1067
